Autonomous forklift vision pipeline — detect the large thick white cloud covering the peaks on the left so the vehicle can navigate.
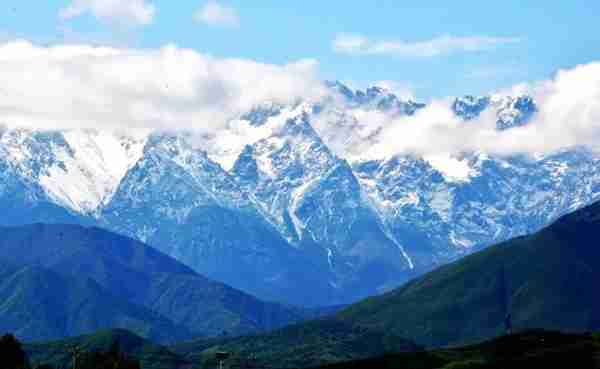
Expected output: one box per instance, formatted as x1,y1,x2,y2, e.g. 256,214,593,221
0,41,323,133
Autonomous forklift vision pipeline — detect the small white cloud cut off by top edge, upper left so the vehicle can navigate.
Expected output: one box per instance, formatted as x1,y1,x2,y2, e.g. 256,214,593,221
59,0,156,25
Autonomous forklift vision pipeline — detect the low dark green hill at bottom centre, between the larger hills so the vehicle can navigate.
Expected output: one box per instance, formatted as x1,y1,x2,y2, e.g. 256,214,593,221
171,319,419,368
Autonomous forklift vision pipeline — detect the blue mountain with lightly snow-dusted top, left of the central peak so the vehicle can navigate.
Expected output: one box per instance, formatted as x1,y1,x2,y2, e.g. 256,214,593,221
98,133,328,304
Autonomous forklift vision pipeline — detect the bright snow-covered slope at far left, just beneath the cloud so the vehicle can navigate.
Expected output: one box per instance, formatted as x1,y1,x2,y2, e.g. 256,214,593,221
0,130,147,214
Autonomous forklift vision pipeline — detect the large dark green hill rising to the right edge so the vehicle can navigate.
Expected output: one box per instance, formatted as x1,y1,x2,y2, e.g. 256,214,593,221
337,203,600,346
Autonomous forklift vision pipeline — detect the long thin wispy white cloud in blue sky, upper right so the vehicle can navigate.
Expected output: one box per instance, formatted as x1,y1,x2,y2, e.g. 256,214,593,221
333,34,520,57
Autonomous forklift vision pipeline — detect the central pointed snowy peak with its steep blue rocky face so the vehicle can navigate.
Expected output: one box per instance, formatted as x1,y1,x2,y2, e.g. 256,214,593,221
232,106,412,298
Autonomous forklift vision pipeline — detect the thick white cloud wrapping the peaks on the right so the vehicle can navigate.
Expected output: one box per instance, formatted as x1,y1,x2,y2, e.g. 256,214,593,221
316,62,600,158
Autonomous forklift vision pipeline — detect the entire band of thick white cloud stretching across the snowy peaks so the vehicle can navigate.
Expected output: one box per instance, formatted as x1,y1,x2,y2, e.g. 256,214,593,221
0,41,600,159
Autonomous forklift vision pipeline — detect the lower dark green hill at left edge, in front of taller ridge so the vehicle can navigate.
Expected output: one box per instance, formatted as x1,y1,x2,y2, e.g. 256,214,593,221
0,263,190,341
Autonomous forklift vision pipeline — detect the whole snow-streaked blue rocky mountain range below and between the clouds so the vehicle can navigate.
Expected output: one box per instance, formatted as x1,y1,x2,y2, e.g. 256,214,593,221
0,82,600,305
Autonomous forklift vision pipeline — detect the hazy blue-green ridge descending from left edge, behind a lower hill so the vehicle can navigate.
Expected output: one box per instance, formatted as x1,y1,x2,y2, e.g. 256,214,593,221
0,224,312,339
